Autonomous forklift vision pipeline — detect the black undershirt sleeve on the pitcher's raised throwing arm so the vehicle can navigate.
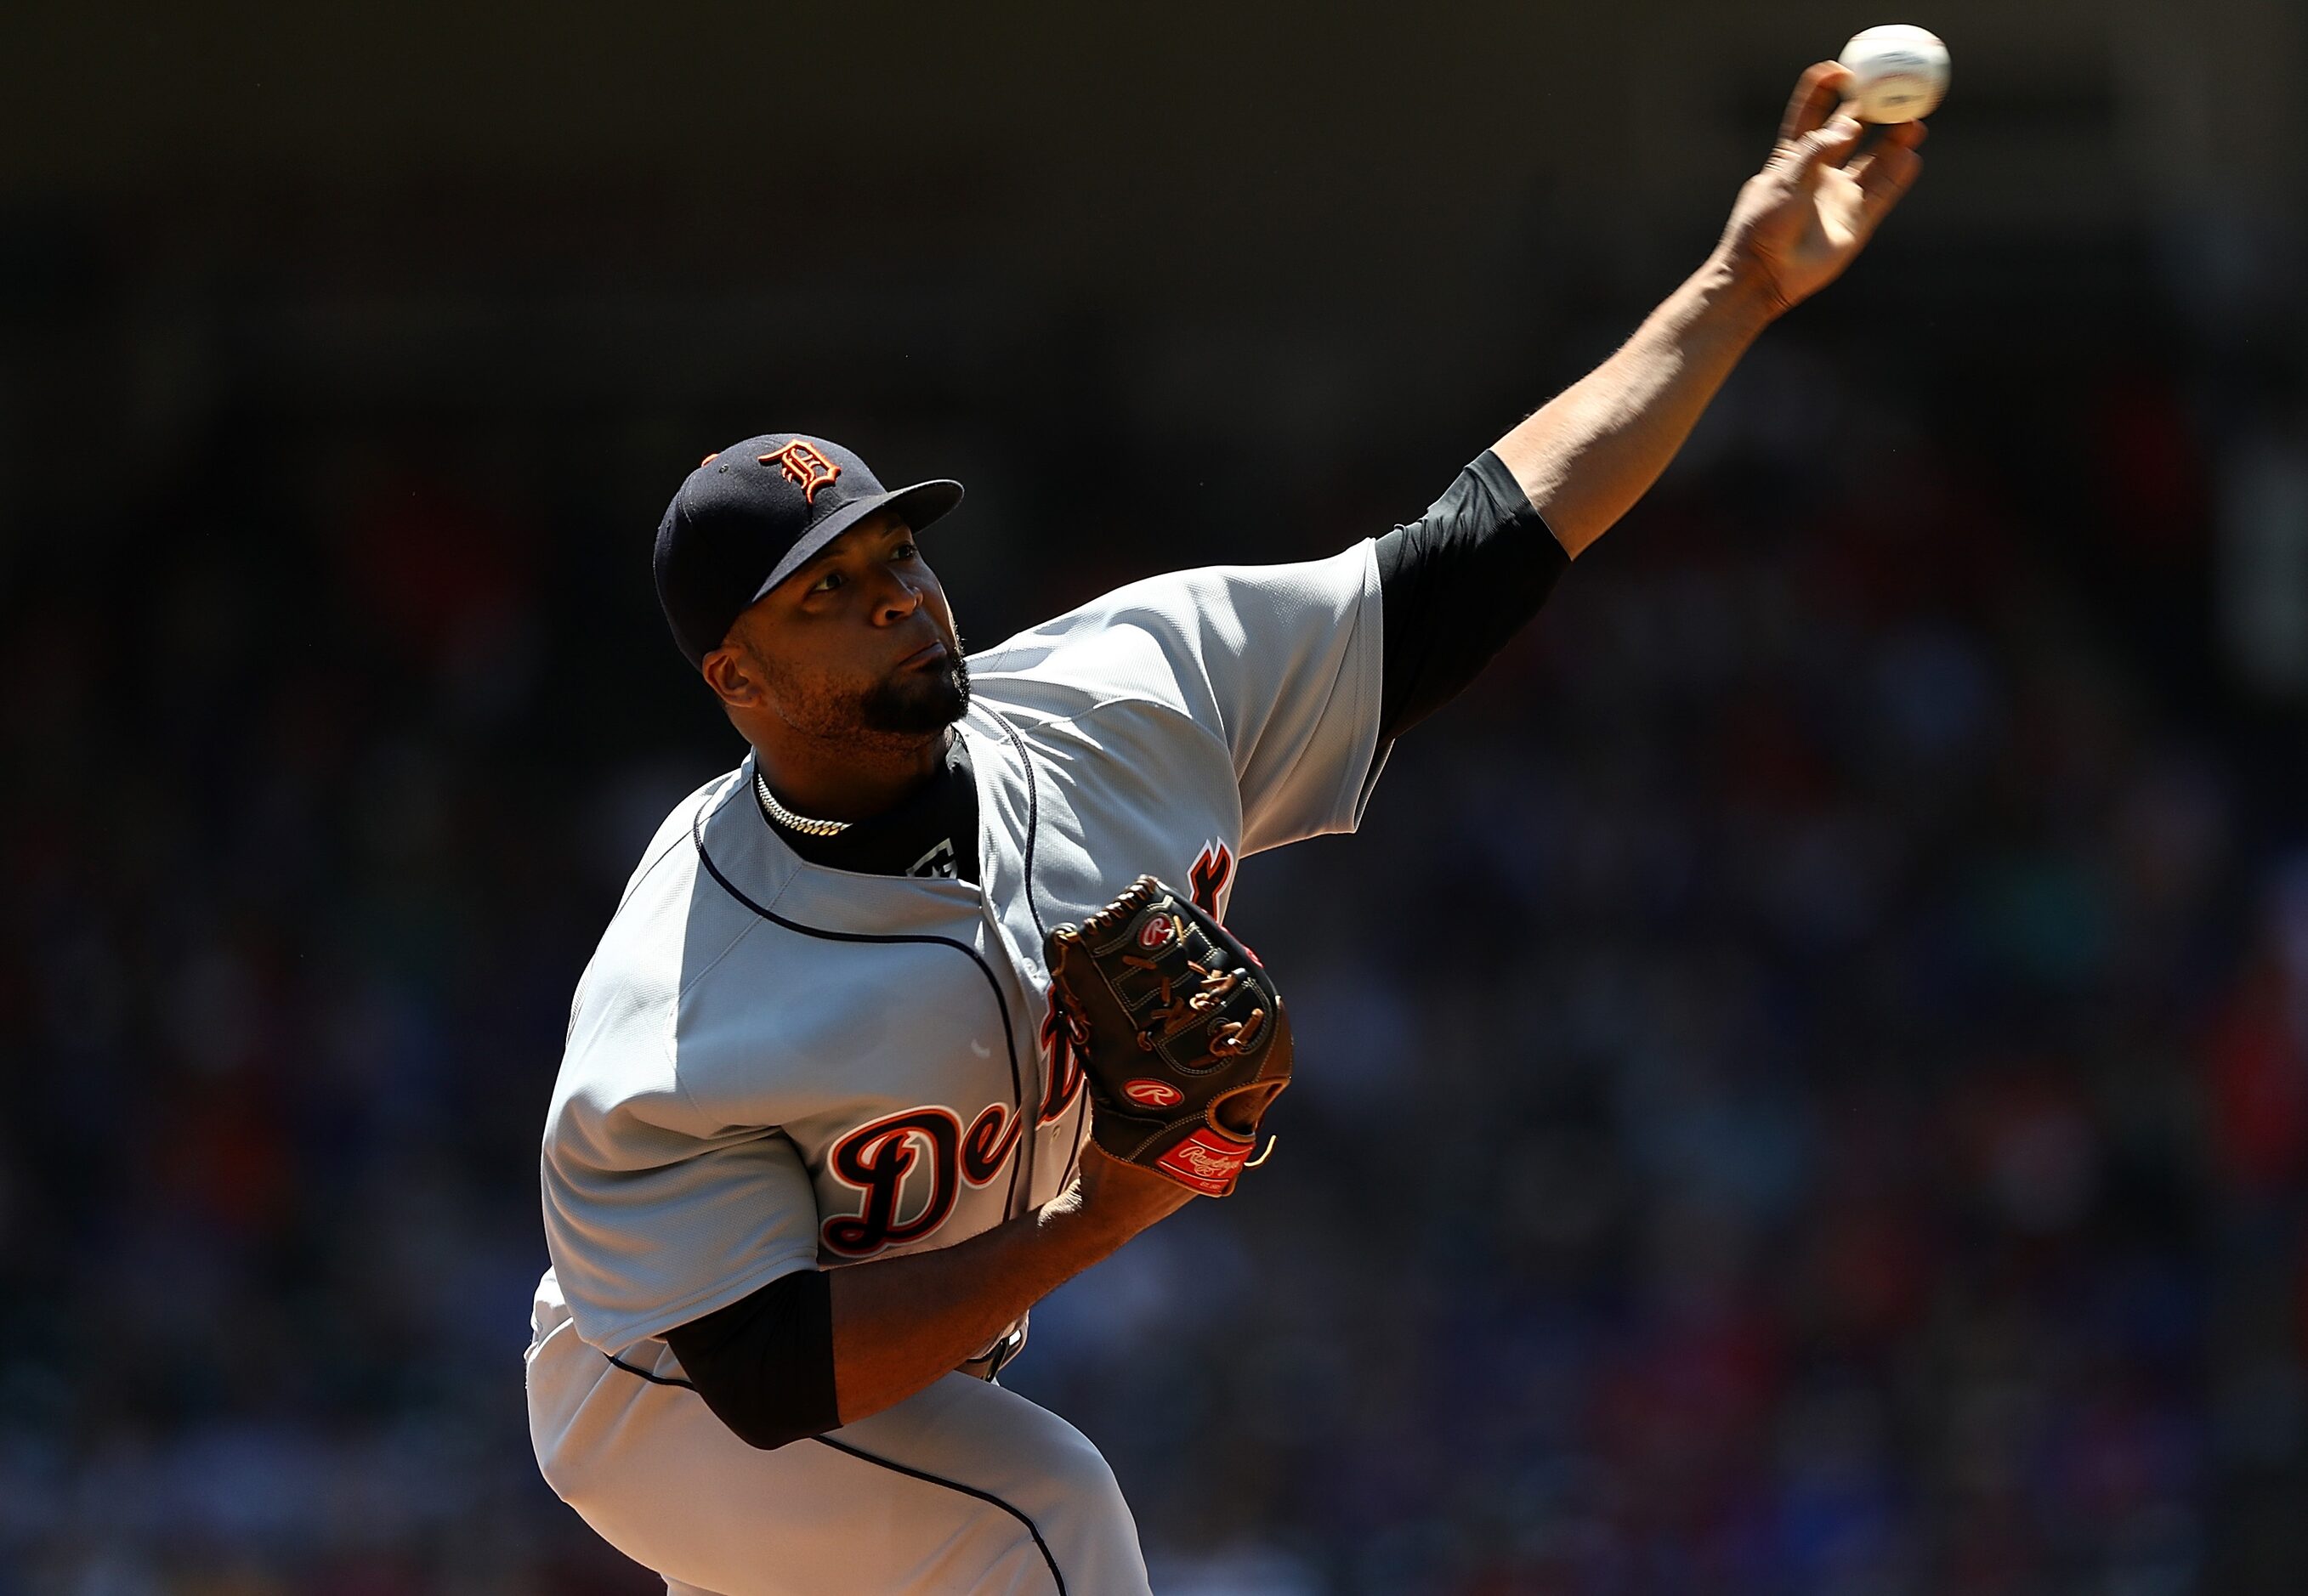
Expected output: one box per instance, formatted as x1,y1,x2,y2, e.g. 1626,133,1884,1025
1378,450,1569,747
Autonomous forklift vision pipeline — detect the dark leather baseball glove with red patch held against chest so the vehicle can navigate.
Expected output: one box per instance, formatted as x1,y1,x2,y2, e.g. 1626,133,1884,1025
1048,876,1290,1197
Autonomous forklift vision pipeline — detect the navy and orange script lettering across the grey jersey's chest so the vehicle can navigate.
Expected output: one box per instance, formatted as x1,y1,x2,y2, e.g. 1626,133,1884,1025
817,842,1235,1257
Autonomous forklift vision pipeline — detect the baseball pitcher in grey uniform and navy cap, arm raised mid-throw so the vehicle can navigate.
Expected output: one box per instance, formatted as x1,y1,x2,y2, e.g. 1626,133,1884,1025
529,62,1923,1596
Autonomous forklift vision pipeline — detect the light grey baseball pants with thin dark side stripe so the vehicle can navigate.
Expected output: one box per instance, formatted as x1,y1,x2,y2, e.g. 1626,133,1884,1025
529,1273,1147,1596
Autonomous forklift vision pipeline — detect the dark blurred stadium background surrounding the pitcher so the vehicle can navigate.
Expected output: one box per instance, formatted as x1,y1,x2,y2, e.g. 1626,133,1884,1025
0,0,2308,1596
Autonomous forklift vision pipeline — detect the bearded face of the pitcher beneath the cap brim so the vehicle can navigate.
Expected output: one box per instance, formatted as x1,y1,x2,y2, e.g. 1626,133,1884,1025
729,512,969,738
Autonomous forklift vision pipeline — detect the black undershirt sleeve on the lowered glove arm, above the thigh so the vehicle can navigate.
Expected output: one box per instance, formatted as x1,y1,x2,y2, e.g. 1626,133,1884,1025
665,1269,842,1448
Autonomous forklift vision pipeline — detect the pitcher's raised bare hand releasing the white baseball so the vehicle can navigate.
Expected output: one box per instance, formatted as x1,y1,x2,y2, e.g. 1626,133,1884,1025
1721,60,1923,311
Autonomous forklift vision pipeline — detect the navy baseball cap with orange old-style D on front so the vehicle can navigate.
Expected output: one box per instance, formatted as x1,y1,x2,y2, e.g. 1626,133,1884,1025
653,431,962,666
